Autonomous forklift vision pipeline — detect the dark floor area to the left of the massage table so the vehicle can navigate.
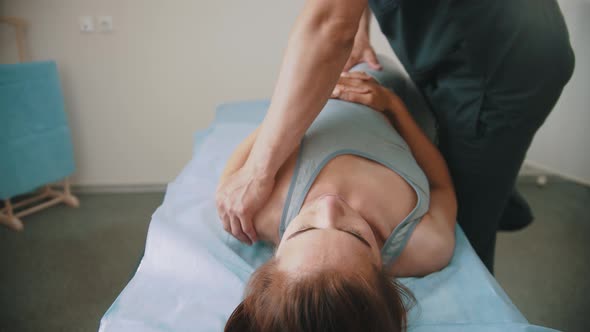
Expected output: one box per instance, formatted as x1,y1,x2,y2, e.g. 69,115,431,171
0,193,163,332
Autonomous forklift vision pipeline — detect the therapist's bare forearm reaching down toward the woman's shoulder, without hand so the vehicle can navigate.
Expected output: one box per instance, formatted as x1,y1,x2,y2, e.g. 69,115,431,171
247,0,366,178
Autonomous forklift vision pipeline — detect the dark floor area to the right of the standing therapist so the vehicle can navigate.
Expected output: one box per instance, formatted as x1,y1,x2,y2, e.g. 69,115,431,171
496,178,590,331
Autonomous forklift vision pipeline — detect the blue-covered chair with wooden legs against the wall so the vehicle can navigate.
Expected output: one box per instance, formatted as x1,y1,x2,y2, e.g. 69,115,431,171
0,19,79,230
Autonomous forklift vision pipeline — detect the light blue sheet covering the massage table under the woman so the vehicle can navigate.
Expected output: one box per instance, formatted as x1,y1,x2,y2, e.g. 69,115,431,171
99,101,553,332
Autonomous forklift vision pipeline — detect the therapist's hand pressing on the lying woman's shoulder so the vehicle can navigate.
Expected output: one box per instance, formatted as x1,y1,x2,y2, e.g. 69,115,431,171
215,165,274,245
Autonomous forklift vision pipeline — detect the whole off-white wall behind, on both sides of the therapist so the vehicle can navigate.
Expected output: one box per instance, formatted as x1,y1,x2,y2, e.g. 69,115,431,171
0,0,590,186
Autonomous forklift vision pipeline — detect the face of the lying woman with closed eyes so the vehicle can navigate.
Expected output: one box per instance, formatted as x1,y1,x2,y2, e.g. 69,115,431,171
275,194,381,273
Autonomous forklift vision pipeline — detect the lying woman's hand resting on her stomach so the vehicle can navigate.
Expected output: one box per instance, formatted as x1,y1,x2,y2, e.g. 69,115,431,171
331,72,399,112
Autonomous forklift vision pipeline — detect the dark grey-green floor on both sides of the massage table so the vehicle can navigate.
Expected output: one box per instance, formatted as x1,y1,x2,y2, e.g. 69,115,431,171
0,179,590,332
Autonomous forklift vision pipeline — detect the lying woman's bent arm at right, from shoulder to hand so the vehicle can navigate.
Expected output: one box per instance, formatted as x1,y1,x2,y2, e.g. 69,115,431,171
332,72,457,277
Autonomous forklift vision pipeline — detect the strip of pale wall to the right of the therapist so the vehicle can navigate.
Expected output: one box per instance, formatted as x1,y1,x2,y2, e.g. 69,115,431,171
527,0,590,184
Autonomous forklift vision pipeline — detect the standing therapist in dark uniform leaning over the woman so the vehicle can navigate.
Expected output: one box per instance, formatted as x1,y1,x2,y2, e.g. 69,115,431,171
216,0,574,272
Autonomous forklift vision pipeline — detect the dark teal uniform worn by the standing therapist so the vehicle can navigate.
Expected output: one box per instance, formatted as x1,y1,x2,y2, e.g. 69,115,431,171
369,0,574,271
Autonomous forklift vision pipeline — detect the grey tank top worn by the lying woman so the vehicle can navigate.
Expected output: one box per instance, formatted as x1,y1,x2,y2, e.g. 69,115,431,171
279,61,430,266
